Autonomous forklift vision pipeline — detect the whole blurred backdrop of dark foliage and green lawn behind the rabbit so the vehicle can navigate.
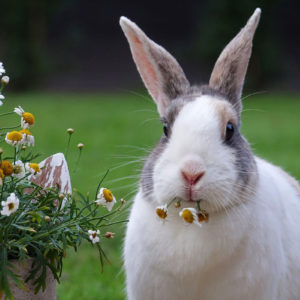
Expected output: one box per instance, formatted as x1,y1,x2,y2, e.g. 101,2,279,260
0,0,300,300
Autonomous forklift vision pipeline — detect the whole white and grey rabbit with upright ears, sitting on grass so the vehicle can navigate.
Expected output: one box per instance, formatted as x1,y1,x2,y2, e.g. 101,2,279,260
120,8,300,300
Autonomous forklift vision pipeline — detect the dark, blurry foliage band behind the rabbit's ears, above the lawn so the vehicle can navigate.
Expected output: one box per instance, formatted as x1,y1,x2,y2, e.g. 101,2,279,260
0,0,300,91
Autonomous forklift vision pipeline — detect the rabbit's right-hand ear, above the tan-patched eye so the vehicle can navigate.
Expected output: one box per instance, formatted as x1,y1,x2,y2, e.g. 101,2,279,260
209,8,261,115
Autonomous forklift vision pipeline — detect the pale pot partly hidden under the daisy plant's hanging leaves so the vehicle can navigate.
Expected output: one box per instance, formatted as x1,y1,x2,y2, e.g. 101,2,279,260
1,259,57,300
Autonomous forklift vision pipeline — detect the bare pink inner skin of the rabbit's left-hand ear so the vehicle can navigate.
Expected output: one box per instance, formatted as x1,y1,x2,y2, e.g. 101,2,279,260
130,34,158,103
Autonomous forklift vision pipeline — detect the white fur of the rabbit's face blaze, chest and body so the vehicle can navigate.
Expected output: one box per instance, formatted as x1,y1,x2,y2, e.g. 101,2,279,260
124,96,300,300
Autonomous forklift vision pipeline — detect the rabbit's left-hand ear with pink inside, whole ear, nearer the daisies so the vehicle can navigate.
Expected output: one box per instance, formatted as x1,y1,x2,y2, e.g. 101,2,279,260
120,17,190,115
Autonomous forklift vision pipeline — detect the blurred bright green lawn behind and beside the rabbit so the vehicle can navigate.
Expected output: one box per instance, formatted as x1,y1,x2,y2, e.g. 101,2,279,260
0,93,300,300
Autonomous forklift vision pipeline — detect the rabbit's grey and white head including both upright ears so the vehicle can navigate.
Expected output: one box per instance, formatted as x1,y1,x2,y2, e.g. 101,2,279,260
120,9,260,212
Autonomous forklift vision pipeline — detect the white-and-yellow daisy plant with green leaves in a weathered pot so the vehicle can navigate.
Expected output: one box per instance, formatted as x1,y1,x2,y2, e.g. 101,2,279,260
0,63,125,300
